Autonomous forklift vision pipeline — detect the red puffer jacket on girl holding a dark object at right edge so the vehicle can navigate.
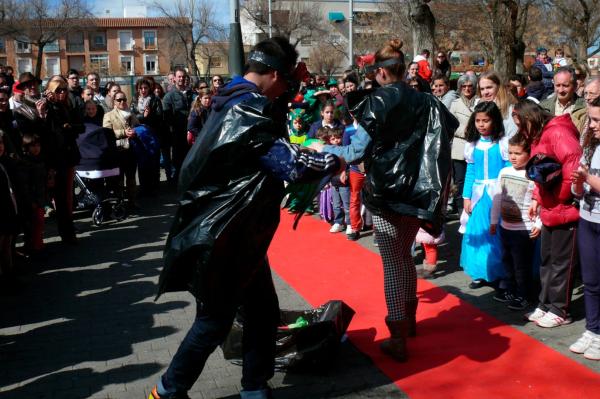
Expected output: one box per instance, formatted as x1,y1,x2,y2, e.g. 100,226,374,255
531,114,582,227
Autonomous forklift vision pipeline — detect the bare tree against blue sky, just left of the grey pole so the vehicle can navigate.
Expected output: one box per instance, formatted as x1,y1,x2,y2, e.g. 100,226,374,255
151,0,225,76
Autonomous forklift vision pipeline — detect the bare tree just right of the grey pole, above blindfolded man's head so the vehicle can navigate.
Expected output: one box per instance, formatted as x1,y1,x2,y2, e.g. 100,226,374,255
242,0,329,47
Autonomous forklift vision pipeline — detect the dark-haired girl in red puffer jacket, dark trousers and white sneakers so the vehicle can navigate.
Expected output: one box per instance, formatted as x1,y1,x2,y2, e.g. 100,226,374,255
513,101,580,328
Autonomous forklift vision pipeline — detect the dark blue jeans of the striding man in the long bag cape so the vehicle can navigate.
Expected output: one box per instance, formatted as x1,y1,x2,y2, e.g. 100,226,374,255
161,260,279,394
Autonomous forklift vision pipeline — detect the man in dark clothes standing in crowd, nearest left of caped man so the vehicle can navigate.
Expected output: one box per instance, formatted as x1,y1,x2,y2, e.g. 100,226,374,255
161,68,193,183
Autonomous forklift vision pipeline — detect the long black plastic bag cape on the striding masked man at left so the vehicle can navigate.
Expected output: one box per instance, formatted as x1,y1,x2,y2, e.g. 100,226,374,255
157,91,285,307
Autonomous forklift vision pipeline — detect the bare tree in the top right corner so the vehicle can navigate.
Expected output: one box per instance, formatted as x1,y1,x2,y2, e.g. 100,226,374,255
544,0,600,63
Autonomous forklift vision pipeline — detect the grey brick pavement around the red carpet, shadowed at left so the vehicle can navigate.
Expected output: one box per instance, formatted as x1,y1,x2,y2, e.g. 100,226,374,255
0,185,600,399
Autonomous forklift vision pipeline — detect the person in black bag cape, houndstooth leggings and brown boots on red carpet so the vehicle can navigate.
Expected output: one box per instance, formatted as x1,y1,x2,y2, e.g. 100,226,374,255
311,40,458,361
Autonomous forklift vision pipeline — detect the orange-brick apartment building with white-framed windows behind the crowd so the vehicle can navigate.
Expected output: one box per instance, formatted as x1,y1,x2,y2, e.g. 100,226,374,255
0,18,191,78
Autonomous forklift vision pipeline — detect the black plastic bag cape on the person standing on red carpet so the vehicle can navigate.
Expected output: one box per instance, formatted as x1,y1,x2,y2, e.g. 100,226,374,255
347,83,458,236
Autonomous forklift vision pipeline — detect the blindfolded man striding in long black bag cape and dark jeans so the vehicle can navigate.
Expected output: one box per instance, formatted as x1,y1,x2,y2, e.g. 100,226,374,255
150,38,344,399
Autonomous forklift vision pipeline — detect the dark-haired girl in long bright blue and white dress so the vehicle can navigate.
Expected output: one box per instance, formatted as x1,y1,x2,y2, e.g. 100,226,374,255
459,102,510,288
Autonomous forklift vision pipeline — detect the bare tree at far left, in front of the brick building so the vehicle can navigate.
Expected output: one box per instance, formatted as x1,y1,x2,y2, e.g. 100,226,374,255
0,0,91,78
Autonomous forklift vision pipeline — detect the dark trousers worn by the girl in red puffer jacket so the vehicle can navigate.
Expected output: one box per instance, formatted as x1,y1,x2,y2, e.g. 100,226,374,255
539,223,579,317
